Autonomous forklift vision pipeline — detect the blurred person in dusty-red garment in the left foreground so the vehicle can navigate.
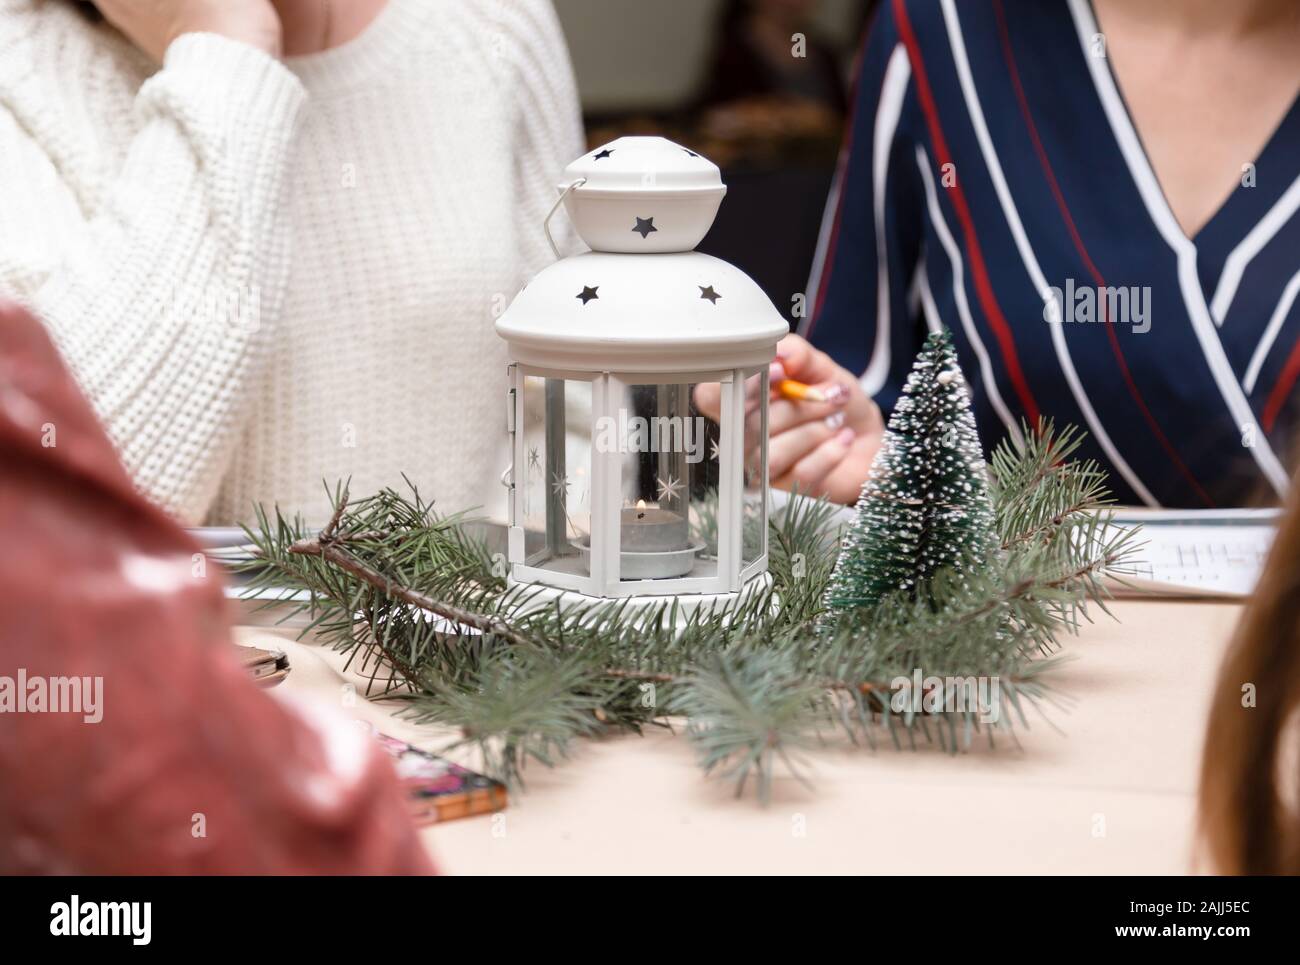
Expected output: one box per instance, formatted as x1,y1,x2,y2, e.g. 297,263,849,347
0,300,432,875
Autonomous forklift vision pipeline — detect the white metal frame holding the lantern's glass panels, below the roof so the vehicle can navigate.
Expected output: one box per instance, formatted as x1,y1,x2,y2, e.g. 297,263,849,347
502,362,768,598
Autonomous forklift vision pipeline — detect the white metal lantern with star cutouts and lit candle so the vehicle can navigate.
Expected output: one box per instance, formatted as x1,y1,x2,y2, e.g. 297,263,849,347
497,137,788,600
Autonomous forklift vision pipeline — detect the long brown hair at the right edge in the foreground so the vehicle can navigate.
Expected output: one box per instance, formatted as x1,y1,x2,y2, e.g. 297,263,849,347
1200,480,1300,874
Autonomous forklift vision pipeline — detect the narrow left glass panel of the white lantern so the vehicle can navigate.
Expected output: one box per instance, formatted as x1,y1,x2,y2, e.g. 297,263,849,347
520,375,592,576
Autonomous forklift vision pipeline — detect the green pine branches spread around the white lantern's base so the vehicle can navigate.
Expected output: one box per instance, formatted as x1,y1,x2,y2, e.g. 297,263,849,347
239,408,1134,799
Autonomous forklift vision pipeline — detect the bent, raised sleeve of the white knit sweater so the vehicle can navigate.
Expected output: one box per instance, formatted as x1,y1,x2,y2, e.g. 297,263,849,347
0,34,306,522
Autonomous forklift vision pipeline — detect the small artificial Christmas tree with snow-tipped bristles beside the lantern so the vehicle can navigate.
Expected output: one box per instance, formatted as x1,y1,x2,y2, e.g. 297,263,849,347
819,329,998,627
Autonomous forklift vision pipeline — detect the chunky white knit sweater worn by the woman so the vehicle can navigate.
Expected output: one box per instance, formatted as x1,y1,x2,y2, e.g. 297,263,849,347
0,0,582,523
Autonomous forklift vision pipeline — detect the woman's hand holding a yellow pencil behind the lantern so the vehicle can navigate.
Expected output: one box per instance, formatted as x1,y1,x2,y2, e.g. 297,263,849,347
696,336,884,503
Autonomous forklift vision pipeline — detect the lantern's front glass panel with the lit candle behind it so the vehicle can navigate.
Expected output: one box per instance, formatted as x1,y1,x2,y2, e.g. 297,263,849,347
616,382,731,581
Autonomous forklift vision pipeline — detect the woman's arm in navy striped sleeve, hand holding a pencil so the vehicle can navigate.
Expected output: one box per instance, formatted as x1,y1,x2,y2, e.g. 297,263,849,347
733,4,924,502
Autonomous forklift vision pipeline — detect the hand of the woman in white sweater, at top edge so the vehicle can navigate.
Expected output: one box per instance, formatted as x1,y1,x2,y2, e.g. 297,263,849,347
95,0,281,64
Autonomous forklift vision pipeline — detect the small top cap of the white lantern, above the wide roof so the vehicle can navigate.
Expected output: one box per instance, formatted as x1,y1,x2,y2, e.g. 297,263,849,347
559,137,727,254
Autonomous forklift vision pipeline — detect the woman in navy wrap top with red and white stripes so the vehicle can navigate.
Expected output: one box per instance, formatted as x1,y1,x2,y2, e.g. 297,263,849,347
707,0,1300,507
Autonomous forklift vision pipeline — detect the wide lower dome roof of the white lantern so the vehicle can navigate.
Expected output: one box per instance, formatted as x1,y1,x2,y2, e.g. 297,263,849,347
497,249,789,373
